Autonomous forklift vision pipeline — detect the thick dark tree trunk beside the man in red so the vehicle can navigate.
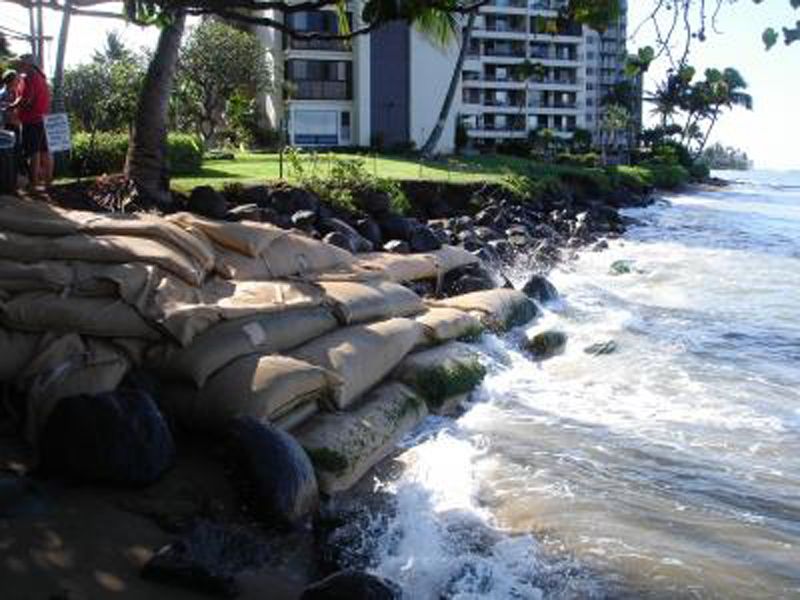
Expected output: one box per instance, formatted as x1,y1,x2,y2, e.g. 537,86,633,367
125,12,186,204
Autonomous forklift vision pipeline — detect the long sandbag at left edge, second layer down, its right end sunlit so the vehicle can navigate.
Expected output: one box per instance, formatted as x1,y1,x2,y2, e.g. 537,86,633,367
0,231,208,285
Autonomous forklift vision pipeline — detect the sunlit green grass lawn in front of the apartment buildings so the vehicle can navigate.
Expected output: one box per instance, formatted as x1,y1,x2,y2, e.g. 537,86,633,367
172,153,532,191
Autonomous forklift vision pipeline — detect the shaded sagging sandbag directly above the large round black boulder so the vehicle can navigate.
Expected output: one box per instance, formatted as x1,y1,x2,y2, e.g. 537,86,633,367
17,334,130,442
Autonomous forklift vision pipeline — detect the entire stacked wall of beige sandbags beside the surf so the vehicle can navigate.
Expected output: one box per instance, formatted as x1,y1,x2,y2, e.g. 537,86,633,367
0,197,535,493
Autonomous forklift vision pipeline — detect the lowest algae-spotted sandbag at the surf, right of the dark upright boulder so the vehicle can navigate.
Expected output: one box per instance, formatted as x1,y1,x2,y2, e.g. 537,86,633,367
293,383,428,495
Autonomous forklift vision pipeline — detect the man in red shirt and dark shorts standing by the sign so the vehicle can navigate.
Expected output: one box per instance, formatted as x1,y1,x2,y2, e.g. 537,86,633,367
11,55,53,189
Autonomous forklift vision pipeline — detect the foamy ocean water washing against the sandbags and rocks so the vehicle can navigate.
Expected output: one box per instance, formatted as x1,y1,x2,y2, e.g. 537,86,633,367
360,172,800,600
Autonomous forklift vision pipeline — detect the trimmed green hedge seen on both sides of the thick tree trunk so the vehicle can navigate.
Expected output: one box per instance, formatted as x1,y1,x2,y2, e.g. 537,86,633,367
69,132,203,177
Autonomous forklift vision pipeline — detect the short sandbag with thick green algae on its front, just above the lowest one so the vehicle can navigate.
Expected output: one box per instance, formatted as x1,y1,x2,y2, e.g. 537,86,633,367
393,342,486,413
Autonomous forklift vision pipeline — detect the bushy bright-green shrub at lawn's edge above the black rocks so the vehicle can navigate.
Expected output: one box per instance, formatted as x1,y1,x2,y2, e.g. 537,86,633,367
286,148,411,214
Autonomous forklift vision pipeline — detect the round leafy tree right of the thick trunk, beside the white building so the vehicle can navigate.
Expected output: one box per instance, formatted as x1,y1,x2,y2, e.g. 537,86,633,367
173,20,270,144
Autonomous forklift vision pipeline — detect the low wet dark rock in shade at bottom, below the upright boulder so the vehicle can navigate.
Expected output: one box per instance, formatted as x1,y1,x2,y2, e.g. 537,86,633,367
142,521,269,598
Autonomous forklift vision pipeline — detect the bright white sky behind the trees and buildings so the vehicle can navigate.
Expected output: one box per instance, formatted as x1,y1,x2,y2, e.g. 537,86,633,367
0,0,800,168
